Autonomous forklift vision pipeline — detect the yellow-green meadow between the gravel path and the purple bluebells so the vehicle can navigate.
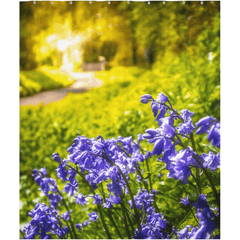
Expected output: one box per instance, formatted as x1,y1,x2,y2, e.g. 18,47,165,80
20,53,220,224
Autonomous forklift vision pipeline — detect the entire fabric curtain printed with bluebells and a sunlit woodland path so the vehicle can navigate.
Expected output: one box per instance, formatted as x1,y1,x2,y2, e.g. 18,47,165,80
19,1,220,239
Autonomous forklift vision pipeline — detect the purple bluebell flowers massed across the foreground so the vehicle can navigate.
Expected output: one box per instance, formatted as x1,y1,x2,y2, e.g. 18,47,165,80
22,93,220,239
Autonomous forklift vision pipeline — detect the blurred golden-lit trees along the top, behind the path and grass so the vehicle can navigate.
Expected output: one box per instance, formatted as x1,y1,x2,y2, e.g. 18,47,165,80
20,1,220,70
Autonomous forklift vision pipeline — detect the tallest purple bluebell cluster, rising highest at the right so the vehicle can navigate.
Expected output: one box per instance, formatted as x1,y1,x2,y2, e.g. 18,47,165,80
142,93,220,183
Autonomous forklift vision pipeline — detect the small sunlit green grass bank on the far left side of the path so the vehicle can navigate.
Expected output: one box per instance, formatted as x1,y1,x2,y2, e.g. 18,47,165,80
19,66,74,97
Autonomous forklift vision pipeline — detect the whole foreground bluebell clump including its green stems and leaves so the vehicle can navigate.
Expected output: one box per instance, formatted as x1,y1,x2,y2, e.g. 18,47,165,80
21,93,220,239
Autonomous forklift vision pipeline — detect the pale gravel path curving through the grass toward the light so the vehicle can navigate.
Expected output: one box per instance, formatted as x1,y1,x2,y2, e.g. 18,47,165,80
20,72,103,106
